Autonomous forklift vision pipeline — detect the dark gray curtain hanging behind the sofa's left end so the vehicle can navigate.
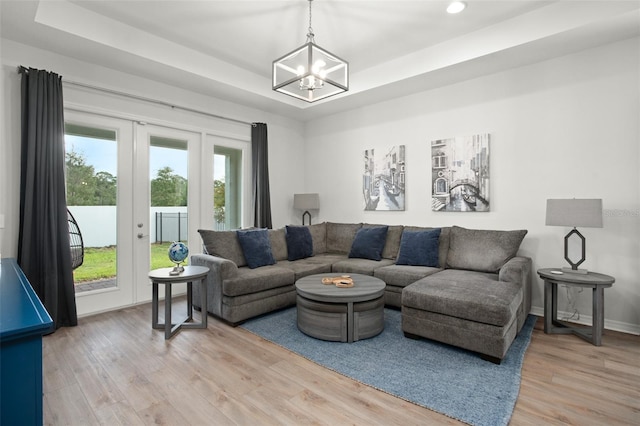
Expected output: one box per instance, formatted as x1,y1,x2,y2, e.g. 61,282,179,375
251,123,273,229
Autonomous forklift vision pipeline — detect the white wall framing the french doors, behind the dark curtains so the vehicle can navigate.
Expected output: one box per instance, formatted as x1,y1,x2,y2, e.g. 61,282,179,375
0,39,304,257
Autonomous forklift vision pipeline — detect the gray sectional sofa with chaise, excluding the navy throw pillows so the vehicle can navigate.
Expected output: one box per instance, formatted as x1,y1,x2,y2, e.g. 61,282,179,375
191,222,531,362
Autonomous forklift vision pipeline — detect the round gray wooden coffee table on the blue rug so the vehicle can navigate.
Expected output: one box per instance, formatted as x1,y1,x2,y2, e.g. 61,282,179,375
296,273,386,343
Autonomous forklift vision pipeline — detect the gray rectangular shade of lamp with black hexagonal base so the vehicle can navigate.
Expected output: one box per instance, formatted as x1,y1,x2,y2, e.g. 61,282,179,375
546,198,602,228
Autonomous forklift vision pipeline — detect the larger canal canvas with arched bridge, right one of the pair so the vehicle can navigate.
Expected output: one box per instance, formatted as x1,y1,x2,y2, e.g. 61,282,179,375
431,133,490,212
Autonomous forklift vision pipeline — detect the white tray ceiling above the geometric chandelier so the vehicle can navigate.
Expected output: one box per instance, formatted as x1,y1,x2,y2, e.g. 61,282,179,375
0,0,640,120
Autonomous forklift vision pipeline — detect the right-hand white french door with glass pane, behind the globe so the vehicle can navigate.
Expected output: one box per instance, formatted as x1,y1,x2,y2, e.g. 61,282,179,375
134,123,200,301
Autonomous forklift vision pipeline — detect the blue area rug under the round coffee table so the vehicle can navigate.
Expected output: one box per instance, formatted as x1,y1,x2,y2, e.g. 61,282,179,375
242,307,536,426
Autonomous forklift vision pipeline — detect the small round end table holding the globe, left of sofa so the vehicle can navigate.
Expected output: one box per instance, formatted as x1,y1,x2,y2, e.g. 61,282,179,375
149,266,209,340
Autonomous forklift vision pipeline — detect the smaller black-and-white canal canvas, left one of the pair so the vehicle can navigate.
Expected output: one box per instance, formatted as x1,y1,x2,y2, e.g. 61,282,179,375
362,145,406,210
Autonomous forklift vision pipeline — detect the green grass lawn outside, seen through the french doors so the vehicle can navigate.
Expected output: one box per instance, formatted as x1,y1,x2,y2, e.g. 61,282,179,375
73,243,188,284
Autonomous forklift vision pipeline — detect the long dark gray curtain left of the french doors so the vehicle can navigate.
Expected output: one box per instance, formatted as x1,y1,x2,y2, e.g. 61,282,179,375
18,68,78,329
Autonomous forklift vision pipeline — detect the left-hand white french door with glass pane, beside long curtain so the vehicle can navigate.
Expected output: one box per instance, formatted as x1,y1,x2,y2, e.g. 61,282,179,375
65,111,133,315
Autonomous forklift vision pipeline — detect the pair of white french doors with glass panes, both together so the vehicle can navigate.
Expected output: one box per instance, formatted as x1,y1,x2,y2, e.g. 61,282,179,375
65,110,202,315
